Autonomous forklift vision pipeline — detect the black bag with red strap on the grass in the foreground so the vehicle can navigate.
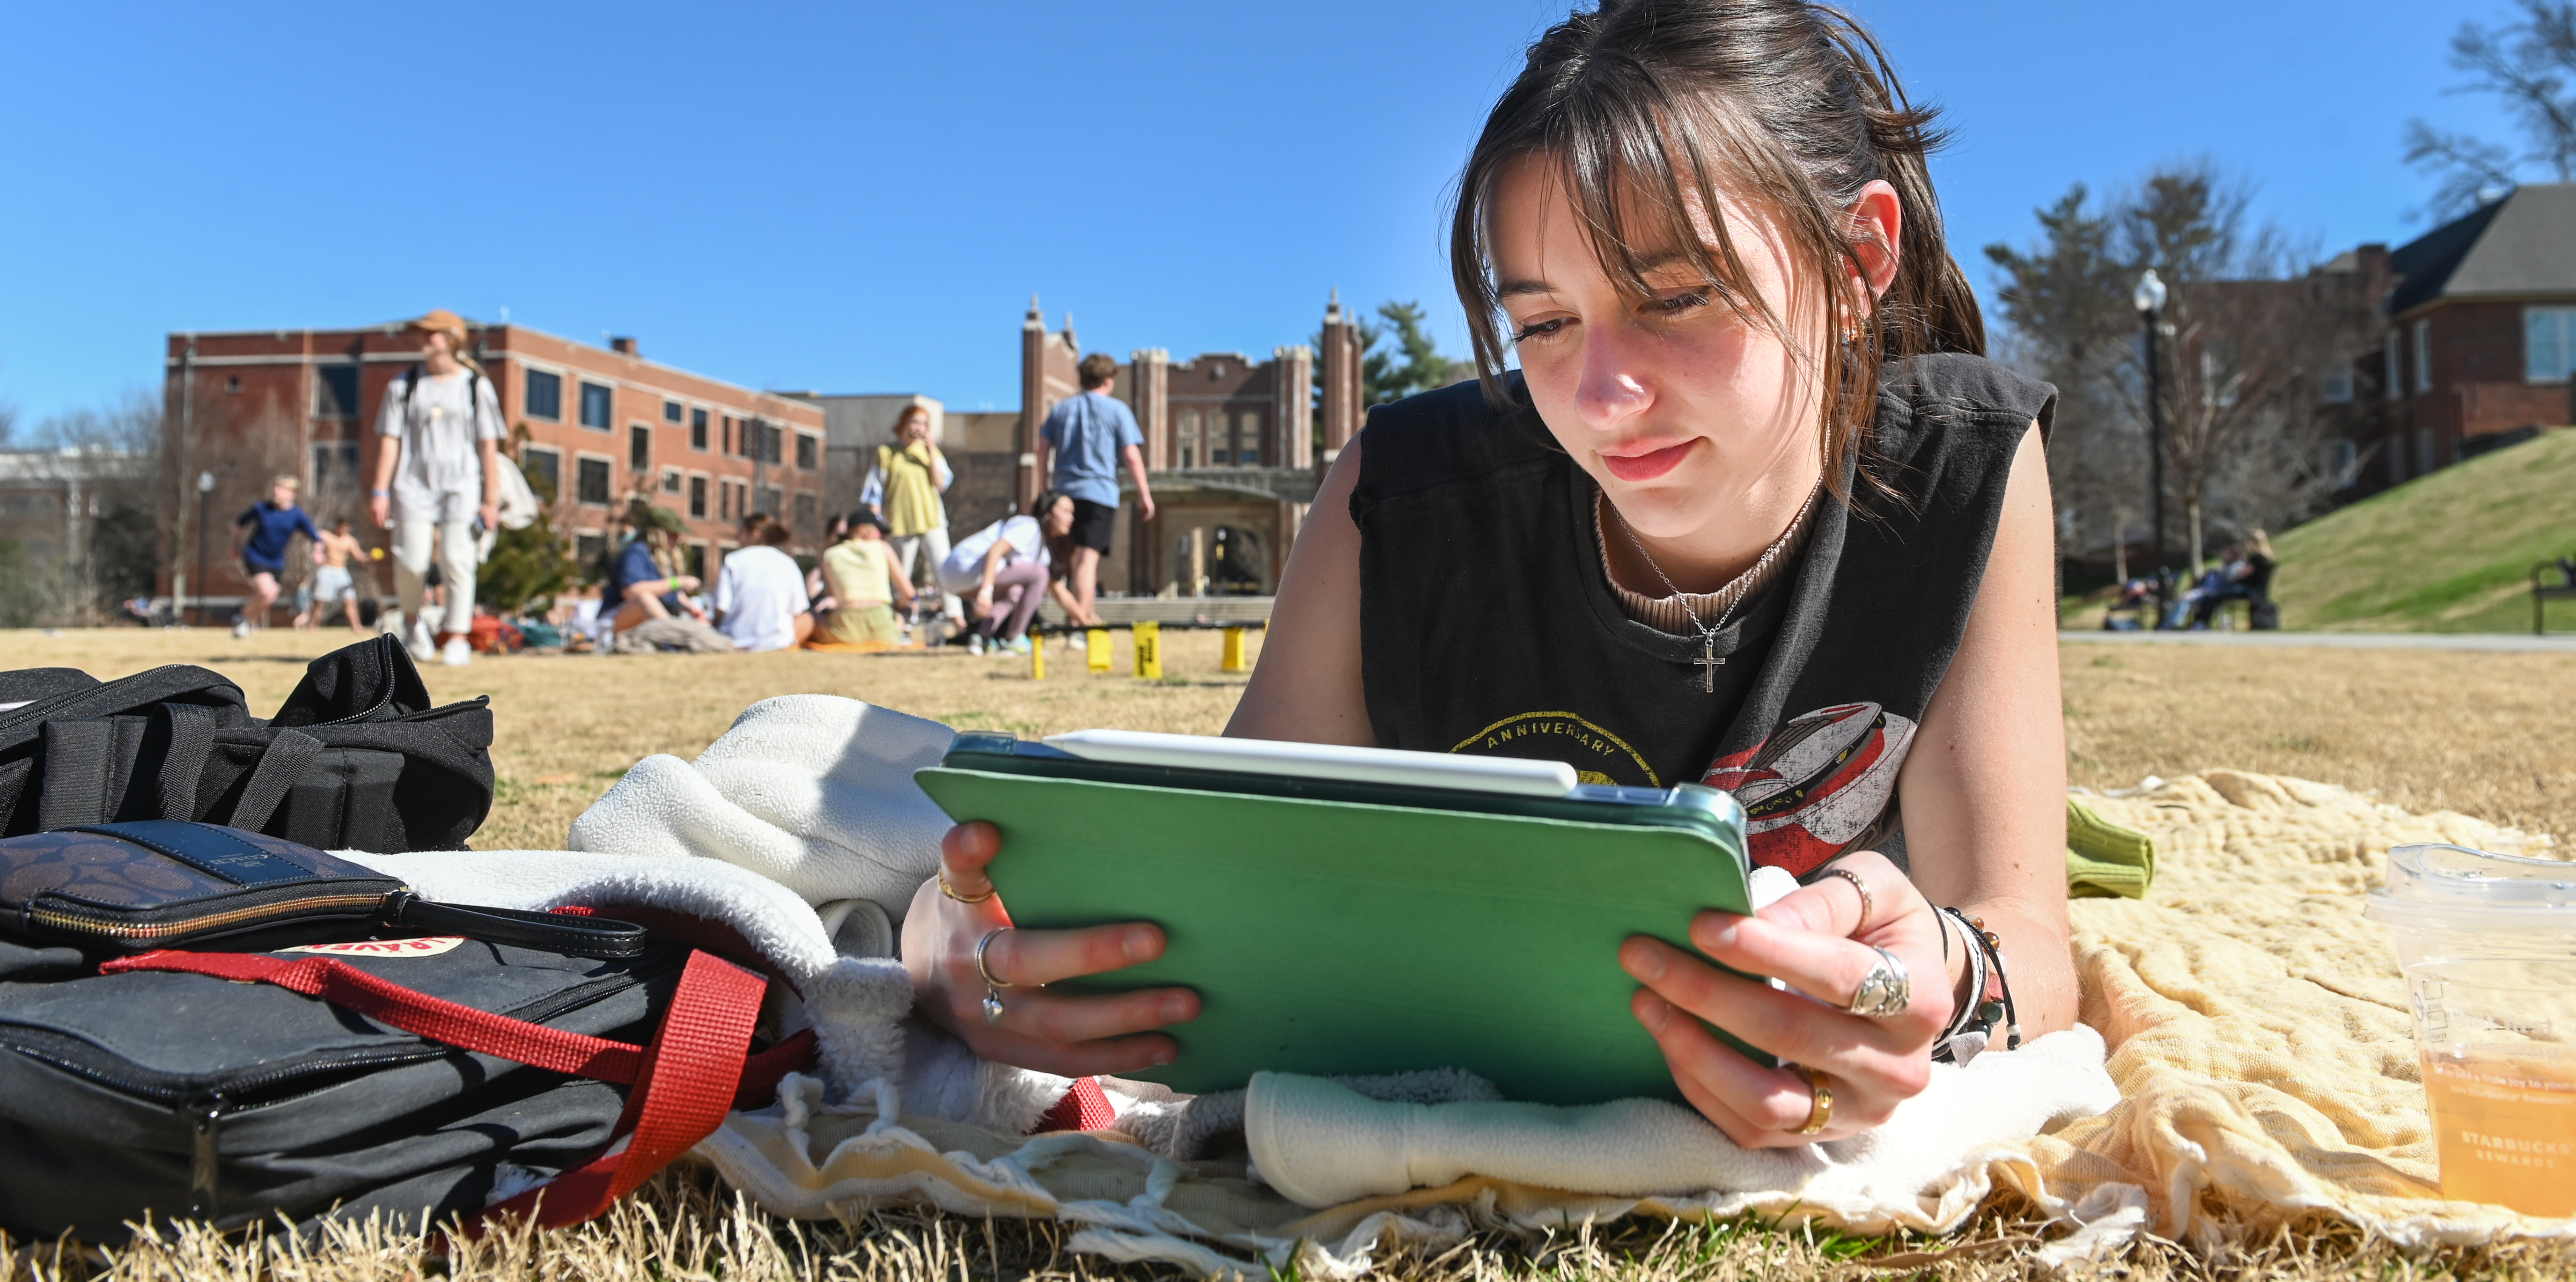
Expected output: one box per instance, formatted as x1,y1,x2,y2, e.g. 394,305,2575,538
0,824,814,1241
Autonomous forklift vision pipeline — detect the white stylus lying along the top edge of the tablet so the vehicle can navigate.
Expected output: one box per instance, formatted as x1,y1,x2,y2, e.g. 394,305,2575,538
1046,731,1582,798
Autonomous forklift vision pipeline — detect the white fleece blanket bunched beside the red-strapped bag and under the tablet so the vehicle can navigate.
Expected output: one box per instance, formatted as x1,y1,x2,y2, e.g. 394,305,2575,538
412,695,2118,1275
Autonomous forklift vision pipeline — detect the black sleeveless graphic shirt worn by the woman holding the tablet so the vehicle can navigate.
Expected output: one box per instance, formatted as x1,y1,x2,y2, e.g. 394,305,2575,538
1350,355,2056,875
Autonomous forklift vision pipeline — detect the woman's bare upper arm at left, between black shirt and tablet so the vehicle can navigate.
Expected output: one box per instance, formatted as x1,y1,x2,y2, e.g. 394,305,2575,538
1226,432,1378,747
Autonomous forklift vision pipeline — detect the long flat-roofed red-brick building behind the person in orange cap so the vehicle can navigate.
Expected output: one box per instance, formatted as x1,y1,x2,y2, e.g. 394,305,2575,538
162,322,824,605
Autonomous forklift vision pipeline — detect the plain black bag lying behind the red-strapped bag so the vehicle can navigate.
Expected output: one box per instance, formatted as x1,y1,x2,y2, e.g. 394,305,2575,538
0,636,492,855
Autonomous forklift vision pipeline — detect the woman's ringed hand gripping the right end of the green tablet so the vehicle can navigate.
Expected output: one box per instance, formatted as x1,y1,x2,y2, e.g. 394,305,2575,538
1618,852,1955,1148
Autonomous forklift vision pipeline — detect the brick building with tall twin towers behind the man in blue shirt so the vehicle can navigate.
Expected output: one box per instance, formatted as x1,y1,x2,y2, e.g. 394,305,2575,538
973,296,1363,597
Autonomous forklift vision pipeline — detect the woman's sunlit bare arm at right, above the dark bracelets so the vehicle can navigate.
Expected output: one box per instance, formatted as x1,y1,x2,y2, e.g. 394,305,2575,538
1896,427,2076,1038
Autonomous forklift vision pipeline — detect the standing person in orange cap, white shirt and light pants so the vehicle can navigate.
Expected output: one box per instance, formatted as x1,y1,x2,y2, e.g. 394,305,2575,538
368,309,510,667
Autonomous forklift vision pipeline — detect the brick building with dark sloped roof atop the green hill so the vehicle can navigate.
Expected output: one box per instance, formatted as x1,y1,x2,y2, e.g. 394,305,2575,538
2324,183,2576,494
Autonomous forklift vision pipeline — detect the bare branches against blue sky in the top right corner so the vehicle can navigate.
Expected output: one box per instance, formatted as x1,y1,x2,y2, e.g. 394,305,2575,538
2406,0,2576,216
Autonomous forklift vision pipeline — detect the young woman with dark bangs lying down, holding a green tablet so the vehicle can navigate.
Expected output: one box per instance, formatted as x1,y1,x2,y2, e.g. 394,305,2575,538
904,0,2076,1146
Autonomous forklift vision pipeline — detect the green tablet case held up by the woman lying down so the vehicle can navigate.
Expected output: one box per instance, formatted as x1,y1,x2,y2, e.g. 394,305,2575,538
914,767,1749,1105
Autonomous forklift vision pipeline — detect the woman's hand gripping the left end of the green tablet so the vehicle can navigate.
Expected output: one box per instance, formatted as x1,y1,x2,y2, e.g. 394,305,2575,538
904,824,1198,1076
